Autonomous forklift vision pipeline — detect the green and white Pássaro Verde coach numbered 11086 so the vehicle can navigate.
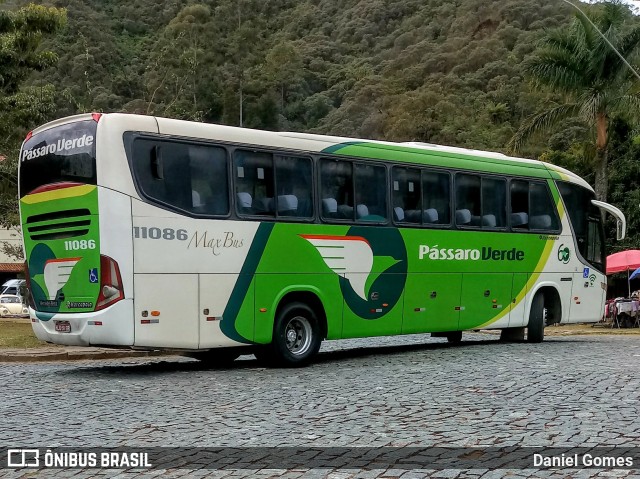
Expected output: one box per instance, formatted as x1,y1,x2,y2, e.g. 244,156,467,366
19,113,626,366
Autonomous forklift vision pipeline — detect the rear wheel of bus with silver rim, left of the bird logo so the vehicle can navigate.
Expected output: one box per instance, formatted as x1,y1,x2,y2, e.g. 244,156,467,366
268,302,322,367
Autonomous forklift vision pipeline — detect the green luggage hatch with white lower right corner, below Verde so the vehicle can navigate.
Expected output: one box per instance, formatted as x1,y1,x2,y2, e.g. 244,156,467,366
460,273,513,330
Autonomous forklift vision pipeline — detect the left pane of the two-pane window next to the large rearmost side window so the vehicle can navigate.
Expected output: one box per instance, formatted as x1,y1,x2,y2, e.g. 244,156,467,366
233,150,275,216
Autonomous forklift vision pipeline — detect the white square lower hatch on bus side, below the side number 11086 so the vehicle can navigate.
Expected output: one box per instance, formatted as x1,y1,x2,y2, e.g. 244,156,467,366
135,274,198,349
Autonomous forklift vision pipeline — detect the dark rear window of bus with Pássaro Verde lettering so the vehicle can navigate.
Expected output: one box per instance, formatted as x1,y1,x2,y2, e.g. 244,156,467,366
20,120,97,197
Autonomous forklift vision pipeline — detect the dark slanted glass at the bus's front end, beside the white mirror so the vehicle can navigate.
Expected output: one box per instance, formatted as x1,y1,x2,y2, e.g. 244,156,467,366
558,181,606,272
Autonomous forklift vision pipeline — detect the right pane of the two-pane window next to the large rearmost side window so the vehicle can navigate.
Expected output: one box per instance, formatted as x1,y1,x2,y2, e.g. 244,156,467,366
275,155,313,218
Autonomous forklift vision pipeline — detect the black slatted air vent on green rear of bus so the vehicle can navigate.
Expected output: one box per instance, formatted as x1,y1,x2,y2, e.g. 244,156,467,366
25,208,91,240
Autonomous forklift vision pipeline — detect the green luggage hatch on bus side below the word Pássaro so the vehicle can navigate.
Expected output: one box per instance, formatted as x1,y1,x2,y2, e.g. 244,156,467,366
402,273,462,334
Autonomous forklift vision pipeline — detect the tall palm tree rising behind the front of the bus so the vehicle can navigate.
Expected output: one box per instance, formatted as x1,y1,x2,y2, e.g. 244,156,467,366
508,1,640,201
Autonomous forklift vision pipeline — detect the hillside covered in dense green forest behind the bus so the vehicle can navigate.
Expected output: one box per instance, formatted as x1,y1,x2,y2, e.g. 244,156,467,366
0,0,640,251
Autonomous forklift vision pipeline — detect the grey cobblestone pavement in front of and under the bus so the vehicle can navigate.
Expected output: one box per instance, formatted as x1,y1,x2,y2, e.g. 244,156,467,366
0,334,640,479
